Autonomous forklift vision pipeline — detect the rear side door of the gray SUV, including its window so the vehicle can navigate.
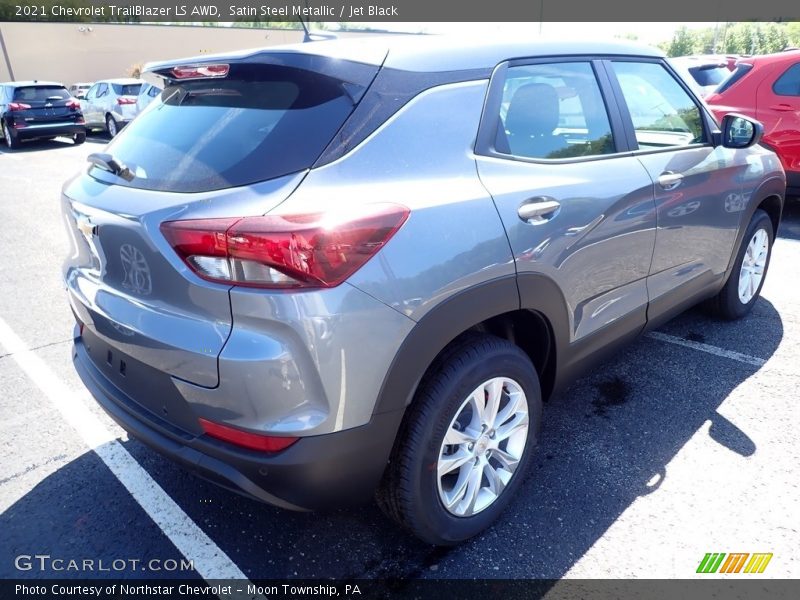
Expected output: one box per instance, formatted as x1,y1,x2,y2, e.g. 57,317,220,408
477,58,655,342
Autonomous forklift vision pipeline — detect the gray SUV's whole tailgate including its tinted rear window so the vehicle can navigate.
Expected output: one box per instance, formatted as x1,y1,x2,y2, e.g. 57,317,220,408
63,55,378,387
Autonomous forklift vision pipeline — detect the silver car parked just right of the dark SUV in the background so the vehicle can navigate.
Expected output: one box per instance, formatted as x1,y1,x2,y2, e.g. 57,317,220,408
81,79,144,138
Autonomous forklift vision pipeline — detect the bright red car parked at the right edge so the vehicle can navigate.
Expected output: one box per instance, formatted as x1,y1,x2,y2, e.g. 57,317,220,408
706,50,800,195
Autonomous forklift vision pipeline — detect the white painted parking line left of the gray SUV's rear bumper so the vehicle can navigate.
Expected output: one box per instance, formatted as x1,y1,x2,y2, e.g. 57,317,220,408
0,319,247,580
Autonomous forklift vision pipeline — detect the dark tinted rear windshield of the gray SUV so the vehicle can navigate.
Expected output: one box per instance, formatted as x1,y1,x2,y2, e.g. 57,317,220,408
90,57,377,192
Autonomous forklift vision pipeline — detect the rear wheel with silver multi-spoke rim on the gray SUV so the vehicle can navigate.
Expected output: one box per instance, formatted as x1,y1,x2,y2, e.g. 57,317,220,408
378,335,542,545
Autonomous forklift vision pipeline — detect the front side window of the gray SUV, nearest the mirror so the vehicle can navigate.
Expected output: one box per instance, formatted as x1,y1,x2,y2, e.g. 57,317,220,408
611,61,705,150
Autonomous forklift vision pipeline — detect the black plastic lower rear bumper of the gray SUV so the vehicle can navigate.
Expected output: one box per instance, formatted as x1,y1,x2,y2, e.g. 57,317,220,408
73,337,403,510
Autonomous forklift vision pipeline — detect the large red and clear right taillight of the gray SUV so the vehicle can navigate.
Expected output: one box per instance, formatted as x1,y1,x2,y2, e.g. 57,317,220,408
161,204,409,288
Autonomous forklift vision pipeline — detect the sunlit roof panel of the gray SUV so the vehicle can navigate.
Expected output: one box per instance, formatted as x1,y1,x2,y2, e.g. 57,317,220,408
145,35,664,72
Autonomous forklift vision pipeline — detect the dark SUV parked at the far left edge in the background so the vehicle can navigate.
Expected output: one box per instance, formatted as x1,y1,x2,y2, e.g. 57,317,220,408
0,81,86,149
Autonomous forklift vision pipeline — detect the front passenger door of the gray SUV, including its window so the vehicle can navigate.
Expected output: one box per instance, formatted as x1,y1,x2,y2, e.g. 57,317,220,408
605,58,748,319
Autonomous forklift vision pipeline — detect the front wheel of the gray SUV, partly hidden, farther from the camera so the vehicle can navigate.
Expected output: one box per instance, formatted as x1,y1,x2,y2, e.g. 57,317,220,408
711,209,774,320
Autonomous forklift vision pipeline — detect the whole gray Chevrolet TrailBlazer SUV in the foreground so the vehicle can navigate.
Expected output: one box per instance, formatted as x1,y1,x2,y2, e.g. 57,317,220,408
63,38,786,544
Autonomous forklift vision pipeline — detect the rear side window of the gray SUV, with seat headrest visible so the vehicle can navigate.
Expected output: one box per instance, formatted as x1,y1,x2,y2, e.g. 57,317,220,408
495,62,616,159
